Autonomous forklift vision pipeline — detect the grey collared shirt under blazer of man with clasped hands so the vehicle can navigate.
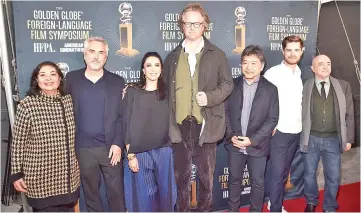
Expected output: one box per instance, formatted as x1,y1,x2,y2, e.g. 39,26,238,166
241,76,259,136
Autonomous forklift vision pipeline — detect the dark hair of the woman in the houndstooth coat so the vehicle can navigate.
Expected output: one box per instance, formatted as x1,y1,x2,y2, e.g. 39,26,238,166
26,61,65,96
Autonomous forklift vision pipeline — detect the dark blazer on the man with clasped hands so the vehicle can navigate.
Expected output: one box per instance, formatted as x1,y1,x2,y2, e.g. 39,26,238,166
225,76,279,157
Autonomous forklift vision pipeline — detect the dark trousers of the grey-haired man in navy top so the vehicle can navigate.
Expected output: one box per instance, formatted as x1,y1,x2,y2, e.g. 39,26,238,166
77,146,125,212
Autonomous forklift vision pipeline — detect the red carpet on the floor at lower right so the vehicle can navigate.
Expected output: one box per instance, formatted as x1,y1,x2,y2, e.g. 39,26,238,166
240,182,360,212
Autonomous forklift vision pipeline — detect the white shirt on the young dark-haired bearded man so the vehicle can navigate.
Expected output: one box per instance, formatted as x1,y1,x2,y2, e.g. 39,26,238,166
264,61,303,134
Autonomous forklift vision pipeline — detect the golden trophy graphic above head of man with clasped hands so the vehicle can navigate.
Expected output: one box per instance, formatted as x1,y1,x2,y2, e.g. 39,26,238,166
232,7,246,55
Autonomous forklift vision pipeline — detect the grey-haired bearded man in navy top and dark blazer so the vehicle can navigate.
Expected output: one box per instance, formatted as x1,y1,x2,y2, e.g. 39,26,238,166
66,37,125,212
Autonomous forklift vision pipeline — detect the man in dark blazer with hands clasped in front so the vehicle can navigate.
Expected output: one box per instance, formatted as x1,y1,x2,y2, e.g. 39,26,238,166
225,45,278,212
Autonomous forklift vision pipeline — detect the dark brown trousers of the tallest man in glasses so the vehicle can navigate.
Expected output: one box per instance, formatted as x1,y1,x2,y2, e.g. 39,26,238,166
172,118,217,212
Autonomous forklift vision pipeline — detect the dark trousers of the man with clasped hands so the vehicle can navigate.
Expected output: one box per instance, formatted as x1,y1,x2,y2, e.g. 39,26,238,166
228,149,267,212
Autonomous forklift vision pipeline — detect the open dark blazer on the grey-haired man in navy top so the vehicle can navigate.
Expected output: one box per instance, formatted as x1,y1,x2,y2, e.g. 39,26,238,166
65,68,125,149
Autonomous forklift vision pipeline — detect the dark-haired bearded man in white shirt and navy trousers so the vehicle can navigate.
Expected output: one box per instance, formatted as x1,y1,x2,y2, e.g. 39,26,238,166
264,35,304,212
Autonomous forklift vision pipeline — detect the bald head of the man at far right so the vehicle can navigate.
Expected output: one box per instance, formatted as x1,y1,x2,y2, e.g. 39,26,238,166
311,55,331,80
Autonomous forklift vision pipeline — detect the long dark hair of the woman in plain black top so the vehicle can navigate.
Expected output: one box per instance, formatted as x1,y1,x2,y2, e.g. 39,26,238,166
138,52,166,100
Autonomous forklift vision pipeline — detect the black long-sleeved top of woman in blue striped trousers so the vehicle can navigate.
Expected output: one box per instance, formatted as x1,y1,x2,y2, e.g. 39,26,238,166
123,86,170,153
